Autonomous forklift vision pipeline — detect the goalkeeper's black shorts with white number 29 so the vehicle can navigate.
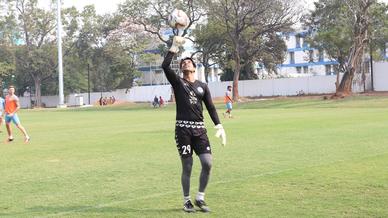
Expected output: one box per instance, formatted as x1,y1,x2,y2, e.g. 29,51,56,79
175,126,212,157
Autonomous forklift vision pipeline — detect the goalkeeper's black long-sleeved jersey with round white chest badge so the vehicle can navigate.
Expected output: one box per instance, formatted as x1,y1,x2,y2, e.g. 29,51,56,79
162,52,220,125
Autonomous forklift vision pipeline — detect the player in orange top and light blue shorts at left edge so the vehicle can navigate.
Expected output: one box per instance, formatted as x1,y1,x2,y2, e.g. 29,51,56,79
4,86,30,143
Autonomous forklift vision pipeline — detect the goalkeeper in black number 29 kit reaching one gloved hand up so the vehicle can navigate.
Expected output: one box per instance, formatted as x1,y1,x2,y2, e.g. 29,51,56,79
162,36,226,212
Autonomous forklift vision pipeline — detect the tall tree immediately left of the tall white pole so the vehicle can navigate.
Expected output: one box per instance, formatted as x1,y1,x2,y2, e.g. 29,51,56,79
4,0,56,106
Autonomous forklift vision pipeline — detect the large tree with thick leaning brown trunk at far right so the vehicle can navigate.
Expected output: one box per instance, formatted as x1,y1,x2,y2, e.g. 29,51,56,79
305,0,387,96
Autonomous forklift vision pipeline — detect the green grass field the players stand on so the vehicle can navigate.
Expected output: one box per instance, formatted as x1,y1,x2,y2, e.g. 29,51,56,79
0,96,388,217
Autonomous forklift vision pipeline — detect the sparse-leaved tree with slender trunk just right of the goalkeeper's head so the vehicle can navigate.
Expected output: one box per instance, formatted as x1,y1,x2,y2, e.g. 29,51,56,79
207,0,297,101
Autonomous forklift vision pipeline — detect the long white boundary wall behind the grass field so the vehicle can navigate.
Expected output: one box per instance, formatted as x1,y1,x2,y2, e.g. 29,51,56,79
20,71,378,108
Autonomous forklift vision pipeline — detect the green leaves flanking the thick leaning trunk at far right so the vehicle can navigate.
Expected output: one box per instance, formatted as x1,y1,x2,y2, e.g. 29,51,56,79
305,0,388,64
